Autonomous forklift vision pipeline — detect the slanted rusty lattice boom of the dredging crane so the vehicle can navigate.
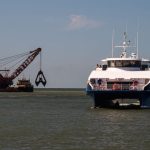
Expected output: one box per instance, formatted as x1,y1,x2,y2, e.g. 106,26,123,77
10,48,42,80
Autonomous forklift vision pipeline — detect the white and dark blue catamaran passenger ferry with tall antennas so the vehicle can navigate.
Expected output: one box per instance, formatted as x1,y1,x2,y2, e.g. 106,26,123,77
86,32,150,108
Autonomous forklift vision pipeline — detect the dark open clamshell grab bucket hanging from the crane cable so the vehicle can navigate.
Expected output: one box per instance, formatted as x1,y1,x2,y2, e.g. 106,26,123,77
35,70,47,86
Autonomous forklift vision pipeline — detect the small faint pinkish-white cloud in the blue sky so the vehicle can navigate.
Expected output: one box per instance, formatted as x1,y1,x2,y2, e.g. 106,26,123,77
68,15,101,30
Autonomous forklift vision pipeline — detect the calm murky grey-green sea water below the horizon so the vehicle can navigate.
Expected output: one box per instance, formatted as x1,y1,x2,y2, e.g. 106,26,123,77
0,89,150,150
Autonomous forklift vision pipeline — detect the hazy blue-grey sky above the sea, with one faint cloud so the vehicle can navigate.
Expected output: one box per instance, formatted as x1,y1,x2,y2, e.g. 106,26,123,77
0,0,150,88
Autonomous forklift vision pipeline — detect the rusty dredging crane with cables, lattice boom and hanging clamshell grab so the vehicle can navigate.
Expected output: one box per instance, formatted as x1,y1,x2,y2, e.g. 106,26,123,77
0,48,47,89
